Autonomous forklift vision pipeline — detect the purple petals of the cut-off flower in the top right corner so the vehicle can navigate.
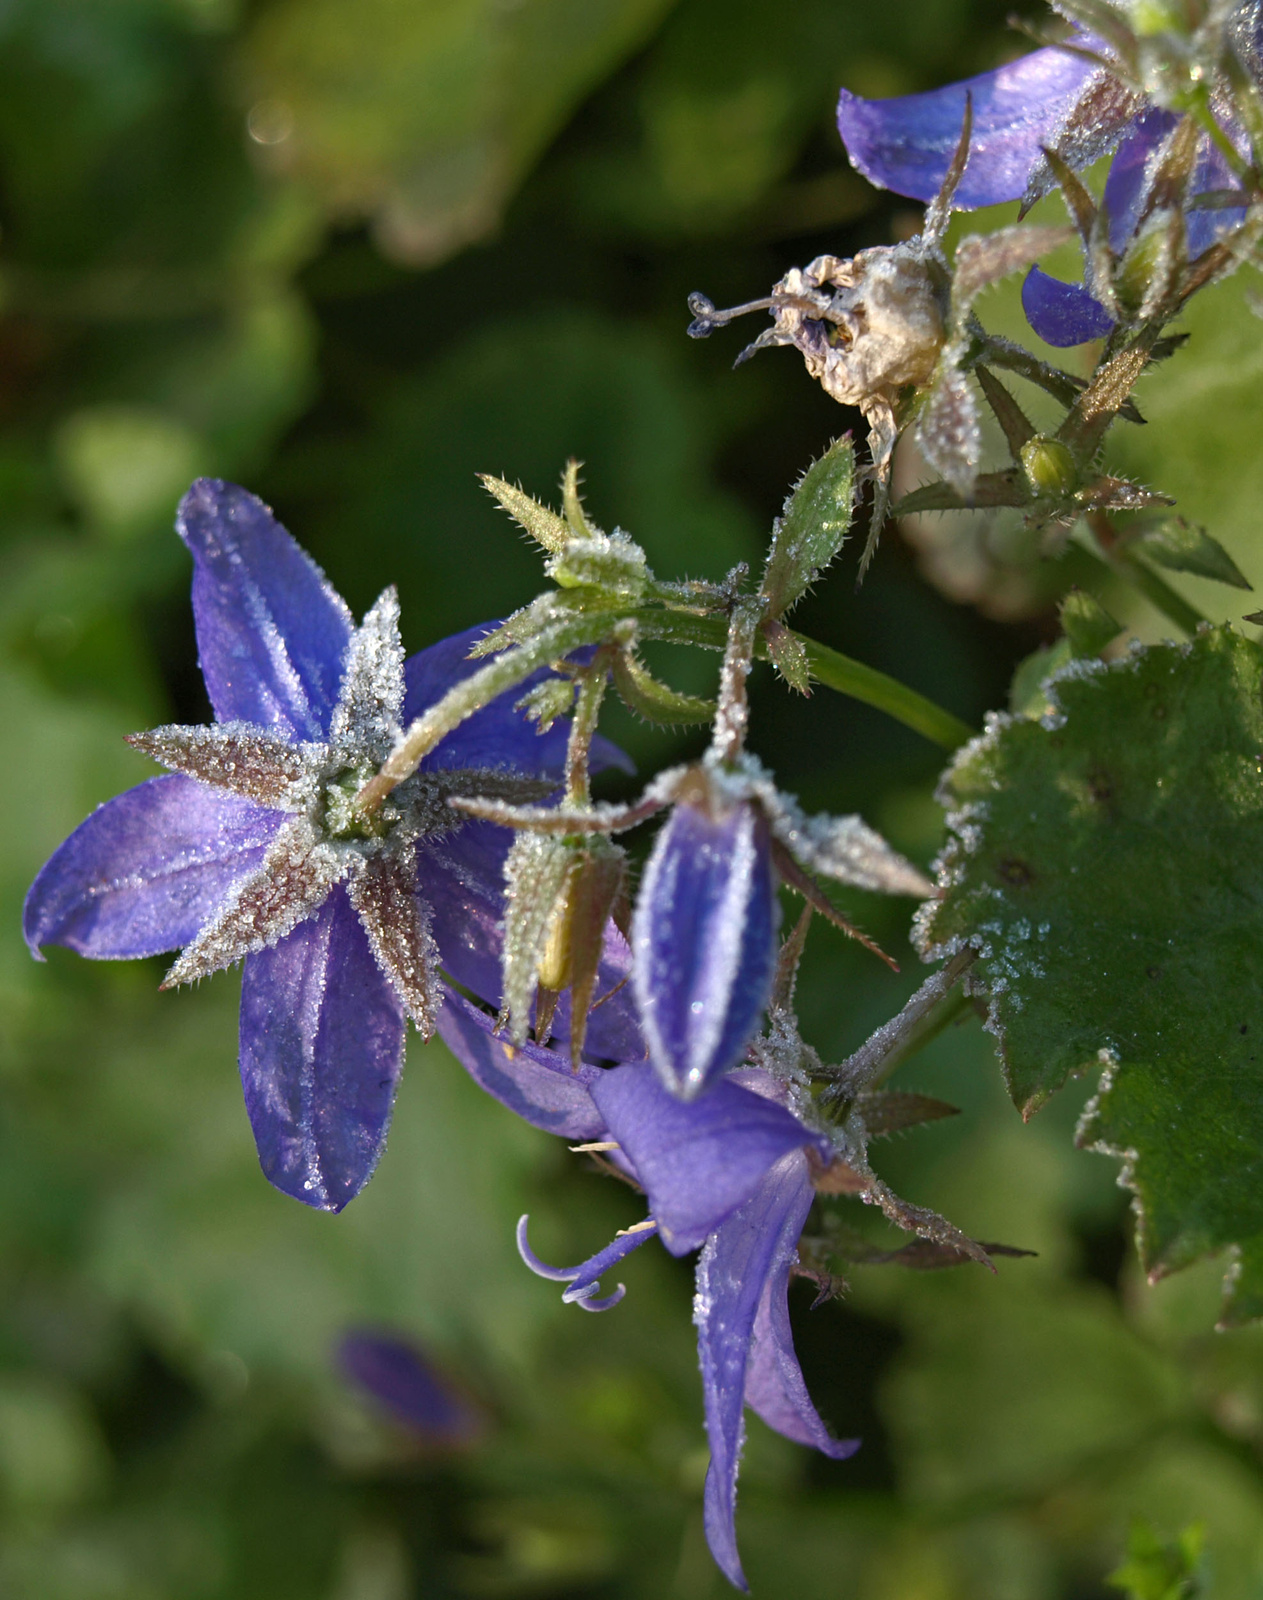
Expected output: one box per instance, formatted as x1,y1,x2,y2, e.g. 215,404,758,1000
837,37,1255,347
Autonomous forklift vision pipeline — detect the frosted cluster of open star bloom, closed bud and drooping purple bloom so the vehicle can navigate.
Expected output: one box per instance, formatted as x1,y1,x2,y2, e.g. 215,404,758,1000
26,480,968,1584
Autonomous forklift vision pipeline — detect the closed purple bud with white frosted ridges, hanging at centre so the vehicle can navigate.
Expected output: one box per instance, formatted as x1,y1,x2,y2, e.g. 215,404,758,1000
631,802,780,1099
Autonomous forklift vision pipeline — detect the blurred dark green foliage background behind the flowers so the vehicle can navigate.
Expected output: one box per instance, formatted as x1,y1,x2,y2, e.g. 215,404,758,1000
0,0,1263,1600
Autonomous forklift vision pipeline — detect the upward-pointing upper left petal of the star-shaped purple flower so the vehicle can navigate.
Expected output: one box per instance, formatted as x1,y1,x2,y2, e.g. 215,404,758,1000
176,478,352,739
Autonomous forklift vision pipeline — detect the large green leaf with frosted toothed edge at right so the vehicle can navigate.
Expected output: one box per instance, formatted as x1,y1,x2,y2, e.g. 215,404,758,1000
917,627,1263,1323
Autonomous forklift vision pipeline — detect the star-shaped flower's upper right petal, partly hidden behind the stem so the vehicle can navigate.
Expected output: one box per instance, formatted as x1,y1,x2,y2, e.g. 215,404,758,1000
403,622,636,776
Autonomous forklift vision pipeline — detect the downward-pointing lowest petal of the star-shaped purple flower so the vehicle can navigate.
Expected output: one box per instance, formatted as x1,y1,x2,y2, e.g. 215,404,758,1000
240,885,403,1211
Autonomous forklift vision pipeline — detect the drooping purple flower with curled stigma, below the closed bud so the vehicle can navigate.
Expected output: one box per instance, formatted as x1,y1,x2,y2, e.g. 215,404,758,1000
439,1002,860,1589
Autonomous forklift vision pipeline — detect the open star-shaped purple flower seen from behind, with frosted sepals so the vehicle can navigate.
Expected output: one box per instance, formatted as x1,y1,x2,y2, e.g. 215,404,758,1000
24,478,634,1211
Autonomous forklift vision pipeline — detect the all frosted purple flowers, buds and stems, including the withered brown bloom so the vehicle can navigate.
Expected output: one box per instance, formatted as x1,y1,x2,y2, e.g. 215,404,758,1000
26,0,1229,1586
